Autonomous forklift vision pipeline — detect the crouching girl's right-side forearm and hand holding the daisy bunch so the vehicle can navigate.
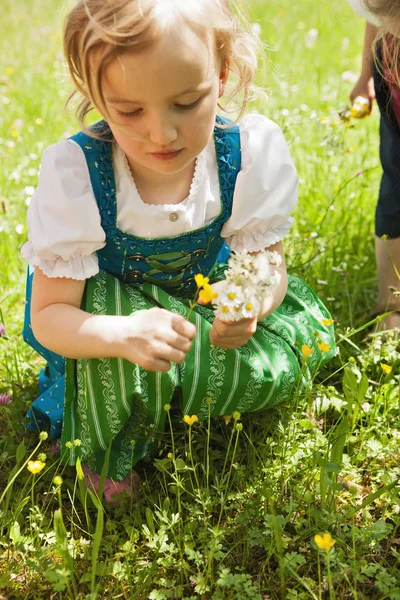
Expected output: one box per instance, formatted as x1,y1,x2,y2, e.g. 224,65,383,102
206,242,288,348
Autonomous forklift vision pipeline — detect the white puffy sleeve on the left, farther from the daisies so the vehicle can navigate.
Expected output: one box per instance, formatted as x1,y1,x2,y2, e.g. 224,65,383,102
21,140,105,280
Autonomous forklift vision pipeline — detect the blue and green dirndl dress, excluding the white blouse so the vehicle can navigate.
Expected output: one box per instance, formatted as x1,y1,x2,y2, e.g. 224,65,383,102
24,117,335,480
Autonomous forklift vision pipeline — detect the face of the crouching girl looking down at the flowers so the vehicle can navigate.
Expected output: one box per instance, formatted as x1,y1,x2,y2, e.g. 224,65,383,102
103,27,228,177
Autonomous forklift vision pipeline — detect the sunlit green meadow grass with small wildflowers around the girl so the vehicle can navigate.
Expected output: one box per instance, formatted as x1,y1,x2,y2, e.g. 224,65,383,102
0,0,400,600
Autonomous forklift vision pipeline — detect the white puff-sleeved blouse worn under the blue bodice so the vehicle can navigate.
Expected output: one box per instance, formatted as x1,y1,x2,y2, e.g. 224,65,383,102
22,114,297,280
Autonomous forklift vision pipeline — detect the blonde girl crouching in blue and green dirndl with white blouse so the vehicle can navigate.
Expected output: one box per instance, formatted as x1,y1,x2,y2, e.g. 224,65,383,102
23,0,334,499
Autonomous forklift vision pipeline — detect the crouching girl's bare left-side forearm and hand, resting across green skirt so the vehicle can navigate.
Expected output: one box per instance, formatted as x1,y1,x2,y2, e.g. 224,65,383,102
31,268,196,372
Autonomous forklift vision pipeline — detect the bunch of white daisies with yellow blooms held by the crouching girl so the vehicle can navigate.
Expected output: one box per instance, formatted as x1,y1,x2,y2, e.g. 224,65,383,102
196,250,282,321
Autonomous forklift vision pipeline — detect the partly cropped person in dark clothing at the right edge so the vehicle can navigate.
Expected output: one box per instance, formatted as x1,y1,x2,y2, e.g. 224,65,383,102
349,0,400,329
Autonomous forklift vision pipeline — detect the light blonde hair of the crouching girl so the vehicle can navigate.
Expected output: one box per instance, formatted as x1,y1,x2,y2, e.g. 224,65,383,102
64,0,261,129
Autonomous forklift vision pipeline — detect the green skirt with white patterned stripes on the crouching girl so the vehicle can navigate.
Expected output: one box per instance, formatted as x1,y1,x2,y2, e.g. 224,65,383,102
62,267,335,480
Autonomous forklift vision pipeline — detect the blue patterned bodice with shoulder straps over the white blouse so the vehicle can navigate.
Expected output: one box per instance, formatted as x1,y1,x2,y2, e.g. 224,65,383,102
71,117,241,297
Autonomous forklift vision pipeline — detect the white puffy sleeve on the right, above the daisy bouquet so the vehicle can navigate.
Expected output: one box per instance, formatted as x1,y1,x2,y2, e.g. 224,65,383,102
221,114,298,252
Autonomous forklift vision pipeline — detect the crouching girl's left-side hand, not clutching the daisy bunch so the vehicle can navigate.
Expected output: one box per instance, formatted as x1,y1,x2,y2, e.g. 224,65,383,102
120,308,196,373
